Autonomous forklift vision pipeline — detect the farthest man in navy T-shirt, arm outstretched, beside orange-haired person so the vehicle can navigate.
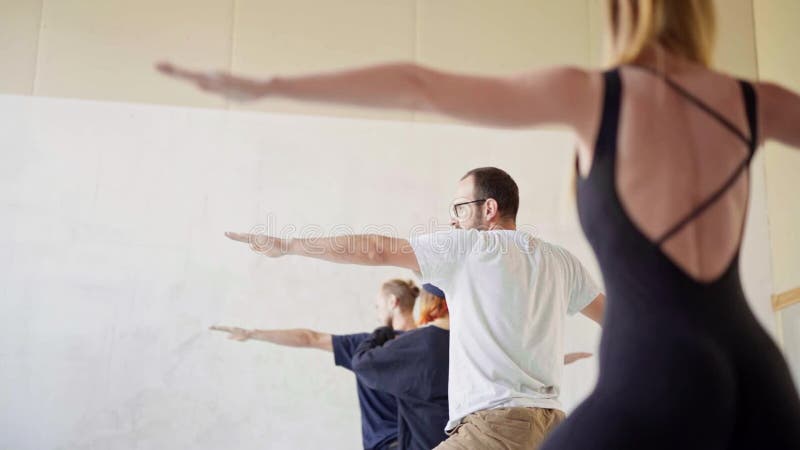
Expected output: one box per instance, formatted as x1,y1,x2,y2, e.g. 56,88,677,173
211,279,420,450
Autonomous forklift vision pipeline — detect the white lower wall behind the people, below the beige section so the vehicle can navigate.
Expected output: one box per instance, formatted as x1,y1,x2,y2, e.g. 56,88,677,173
0,91,770,450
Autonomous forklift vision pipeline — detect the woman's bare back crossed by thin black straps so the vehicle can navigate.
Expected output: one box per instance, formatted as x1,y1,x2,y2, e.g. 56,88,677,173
581,65,751,282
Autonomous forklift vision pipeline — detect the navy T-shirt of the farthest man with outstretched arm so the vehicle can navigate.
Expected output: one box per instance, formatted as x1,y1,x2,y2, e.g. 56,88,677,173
332,333,397,450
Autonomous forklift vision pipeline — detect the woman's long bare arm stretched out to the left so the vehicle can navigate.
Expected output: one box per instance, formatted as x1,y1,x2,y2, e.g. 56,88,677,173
157,59,602,131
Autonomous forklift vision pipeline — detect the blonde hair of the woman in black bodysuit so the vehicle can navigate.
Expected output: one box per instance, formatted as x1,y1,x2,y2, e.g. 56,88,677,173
606,0,716,67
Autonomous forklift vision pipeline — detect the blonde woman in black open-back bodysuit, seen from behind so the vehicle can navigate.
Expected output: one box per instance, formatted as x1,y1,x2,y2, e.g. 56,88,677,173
159,0,800,450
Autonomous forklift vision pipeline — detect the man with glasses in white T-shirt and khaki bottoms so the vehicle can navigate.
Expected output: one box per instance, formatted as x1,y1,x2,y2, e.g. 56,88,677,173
227,167,605,450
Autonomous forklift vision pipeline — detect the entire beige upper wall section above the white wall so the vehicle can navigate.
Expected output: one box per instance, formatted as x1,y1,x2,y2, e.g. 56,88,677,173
0,0,757,107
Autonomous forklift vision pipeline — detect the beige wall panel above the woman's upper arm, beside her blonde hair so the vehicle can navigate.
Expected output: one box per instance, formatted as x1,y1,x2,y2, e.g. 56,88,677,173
418,0,591,74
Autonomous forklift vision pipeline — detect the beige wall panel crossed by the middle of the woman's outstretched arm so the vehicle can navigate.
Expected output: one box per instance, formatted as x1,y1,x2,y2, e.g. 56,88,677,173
230,0,417,120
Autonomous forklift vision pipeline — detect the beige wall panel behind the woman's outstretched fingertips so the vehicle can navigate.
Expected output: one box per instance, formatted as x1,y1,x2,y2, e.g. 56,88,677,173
34,0,233,107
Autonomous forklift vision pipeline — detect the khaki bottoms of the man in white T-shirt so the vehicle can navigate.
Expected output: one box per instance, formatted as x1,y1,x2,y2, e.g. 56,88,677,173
436,408,565,450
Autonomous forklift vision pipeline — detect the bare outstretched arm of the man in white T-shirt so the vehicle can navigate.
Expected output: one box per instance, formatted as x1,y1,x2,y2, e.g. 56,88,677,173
225,232,419,272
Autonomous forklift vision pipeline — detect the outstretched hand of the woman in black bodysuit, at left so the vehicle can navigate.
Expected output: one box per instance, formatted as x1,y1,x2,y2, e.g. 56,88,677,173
156,62,270,102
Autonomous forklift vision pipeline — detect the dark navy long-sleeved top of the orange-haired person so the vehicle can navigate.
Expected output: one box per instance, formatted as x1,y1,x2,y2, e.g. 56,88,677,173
352,326,450,450
